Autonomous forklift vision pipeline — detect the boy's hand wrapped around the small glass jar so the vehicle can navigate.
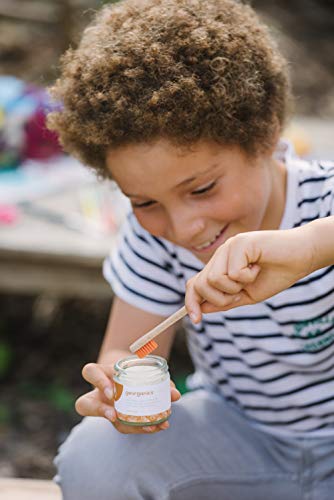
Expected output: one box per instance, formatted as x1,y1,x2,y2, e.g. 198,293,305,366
75,363,181,434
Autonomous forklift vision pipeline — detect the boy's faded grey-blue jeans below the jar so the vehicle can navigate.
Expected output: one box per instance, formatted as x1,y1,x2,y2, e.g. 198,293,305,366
55,390,334,500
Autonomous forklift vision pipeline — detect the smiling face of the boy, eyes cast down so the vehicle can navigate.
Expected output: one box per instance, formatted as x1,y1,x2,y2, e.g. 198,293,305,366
107,140,285,263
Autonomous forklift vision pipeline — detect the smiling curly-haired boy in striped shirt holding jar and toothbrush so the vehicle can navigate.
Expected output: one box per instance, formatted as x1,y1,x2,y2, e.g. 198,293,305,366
50,0,334,500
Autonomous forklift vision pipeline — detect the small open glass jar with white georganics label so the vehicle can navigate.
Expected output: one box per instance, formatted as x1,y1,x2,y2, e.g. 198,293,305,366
114,355,171,426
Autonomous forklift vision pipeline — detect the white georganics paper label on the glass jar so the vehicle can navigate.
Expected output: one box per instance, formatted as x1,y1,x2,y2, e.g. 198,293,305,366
114,376,171,417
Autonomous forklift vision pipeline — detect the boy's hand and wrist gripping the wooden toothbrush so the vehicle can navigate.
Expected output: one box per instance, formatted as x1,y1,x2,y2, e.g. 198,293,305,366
185,226,313,323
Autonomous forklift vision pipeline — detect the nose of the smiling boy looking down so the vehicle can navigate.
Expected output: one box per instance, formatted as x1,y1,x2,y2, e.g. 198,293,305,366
167,206,205,246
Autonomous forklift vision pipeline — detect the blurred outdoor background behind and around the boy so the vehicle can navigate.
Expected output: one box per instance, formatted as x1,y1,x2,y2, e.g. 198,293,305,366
0,0,334,478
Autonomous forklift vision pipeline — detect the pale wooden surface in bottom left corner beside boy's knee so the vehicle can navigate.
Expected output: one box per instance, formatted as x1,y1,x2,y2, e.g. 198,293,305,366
0,478,62,500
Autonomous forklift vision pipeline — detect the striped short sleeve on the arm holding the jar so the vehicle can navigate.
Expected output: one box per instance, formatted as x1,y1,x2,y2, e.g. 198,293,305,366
103,214,184,316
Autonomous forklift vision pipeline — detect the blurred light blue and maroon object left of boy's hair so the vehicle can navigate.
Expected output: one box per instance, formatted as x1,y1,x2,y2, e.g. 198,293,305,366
0,76,62,171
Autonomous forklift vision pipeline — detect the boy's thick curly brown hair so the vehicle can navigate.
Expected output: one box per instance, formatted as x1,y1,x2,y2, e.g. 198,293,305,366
48,0,290,177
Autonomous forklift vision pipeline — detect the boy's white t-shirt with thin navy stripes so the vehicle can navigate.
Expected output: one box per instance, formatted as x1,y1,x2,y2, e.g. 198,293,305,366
104,150,334,436
